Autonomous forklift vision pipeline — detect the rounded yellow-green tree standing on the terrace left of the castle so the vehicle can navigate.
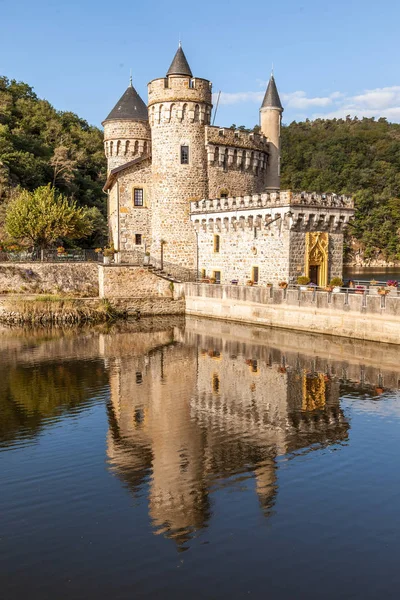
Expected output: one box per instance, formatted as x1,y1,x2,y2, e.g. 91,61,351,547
5,184,94,248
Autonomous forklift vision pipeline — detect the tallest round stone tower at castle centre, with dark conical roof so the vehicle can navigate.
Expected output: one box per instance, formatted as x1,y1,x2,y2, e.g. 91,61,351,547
148,45,212,269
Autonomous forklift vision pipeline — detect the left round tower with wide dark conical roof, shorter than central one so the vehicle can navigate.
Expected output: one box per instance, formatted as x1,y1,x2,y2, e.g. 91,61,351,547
102,79,151,173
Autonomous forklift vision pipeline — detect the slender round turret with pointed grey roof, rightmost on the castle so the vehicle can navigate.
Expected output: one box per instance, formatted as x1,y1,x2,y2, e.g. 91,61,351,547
260,75,283,191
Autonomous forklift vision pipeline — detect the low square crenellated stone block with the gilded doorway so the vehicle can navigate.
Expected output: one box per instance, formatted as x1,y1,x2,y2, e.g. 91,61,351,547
191,192,353,285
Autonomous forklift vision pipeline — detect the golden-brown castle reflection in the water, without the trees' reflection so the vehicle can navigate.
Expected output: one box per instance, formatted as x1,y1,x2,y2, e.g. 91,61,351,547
104,319,386,544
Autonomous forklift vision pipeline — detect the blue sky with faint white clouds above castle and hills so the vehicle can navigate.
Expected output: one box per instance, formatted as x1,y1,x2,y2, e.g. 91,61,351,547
0,0,400,126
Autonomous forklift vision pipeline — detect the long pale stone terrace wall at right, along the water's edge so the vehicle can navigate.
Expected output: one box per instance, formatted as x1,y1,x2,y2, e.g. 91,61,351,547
184,283,400,344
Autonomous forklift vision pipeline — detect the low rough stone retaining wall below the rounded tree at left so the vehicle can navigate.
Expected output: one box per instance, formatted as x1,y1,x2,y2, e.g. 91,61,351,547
0,262,99,297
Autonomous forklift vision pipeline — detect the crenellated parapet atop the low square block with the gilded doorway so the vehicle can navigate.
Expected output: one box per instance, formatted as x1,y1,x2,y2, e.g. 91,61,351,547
190,190,354,215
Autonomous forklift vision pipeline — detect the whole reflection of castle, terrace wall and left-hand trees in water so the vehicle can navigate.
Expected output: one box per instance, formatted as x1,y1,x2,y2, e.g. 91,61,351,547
0,318,399,548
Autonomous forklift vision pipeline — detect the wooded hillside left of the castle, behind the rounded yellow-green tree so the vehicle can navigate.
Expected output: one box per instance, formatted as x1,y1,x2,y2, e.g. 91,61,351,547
0,77,106,244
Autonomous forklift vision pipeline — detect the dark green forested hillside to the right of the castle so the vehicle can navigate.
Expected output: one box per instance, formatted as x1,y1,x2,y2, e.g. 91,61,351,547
281,118,400,260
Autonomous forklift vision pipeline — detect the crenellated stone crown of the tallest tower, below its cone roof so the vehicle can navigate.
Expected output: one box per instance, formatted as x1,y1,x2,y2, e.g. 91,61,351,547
148,77,212,107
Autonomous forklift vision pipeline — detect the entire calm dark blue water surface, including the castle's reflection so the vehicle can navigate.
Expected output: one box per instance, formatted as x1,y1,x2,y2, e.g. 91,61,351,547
0,319,400,600
